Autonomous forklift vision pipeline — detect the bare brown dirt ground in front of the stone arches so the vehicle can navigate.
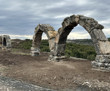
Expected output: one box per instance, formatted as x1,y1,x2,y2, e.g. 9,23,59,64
0,51,110,90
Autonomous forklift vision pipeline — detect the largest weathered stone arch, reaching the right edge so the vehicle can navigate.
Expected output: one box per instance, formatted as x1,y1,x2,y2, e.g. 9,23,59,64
54,15,110,67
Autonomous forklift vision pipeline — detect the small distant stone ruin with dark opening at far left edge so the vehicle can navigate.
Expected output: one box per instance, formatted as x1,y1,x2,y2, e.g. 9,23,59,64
0,35,11,50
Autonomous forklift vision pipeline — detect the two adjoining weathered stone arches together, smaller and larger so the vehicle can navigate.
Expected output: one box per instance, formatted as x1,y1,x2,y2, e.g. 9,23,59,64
31,15,110,68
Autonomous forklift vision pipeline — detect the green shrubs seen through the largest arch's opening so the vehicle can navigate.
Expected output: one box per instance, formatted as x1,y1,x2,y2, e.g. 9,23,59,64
65,43,96,60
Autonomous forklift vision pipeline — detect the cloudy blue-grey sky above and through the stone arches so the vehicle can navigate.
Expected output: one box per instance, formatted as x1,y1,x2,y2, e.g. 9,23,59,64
0,0,110,39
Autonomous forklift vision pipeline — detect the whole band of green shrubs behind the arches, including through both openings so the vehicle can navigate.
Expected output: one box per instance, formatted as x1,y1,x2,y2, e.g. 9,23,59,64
14,39,96,60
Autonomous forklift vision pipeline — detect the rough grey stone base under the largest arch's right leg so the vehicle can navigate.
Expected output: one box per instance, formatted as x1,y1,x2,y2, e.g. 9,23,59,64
92,55,110,70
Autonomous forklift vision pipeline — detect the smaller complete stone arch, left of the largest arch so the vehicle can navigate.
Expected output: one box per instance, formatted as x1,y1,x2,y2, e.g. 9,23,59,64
31,24,57,56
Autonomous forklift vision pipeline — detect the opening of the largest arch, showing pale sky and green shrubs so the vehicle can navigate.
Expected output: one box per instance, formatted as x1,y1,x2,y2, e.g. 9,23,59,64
65,25,96,60
